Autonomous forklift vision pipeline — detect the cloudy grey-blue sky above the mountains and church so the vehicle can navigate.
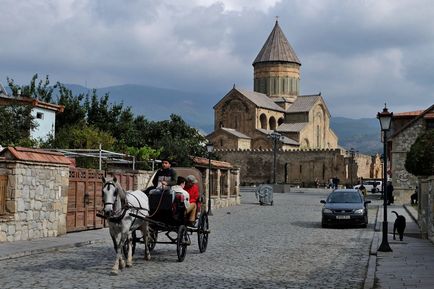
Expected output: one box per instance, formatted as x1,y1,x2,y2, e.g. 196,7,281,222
0,0,434,118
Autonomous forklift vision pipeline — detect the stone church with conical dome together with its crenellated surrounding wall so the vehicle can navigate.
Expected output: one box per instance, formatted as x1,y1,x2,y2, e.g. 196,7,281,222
207,21,381,186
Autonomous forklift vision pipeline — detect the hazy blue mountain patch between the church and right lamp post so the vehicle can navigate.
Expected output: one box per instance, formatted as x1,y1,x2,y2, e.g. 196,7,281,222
330,117,383,154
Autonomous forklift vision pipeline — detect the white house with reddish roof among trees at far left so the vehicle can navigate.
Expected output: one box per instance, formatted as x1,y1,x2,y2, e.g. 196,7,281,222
0,84,64,140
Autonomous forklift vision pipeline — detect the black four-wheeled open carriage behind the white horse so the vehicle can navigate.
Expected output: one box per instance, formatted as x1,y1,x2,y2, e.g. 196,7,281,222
123,167,210,262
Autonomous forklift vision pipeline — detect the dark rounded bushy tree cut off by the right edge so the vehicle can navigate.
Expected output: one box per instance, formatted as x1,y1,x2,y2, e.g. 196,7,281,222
405,129,434,176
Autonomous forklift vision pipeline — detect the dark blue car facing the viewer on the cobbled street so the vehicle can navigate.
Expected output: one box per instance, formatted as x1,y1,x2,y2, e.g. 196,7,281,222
321,189,371,228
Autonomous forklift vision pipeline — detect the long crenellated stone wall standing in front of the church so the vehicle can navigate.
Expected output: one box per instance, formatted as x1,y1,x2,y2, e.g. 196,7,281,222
216,149,372,187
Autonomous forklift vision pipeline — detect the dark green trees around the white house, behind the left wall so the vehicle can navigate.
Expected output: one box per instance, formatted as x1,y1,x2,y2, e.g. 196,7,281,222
0,74,206,169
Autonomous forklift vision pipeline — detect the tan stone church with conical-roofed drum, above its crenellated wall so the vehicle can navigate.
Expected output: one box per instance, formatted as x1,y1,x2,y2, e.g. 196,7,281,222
207,21,338,150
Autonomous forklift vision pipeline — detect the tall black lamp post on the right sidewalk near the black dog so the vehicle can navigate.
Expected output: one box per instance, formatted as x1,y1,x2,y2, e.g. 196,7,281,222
377,104,393,252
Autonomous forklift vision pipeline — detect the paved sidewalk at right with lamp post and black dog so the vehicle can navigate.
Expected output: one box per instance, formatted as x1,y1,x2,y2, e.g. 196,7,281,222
364,205,434,289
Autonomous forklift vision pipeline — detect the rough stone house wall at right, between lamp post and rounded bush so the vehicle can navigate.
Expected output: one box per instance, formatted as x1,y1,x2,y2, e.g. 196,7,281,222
391,118,425,204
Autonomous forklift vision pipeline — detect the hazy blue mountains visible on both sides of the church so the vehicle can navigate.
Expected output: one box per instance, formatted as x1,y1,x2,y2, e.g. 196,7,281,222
66,84,382,154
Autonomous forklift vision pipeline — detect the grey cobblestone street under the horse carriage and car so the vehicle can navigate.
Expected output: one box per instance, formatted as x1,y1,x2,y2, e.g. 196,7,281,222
0,191,376,289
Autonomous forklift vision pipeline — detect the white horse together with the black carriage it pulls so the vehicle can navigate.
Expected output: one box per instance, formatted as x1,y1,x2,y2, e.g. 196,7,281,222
98,167,210,274
